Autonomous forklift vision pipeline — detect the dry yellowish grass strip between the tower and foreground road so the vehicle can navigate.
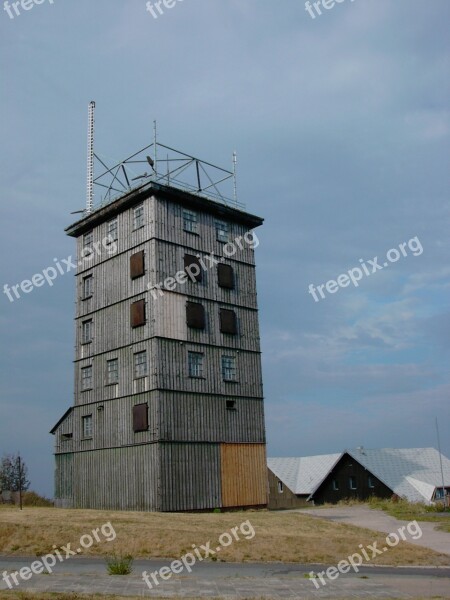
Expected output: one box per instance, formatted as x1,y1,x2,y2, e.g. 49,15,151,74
0,507,450,566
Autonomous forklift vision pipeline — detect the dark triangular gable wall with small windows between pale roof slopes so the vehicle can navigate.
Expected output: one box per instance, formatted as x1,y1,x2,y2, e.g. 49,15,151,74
313,454,393,504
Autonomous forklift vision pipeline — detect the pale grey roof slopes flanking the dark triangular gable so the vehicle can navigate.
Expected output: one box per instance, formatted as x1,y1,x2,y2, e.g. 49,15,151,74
267,448,450,503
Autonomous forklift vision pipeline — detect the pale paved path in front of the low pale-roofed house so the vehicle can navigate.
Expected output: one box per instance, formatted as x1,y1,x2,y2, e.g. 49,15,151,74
298,506,450,564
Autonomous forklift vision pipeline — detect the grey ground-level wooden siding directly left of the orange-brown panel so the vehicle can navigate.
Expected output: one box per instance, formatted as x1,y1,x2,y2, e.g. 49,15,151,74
161,443,221,511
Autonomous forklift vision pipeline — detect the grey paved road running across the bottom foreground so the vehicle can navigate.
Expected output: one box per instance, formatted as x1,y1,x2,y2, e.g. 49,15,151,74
0,557,450,600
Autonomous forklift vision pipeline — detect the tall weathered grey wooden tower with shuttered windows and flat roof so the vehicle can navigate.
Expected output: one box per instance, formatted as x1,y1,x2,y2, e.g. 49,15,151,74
51,138,267,511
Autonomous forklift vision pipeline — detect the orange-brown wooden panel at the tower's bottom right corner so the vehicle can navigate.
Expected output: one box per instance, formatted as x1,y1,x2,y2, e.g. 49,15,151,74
220,444,268,508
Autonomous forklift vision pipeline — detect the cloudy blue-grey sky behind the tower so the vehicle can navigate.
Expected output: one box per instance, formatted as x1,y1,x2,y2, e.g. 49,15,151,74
0,0,450,497
